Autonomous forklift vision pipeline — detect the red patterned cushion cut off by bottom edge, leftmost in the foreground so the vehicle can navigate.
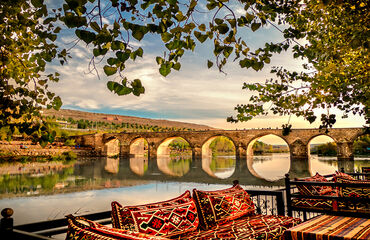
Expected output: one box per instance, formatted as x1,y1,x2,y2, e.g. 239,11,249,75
66,215,167,240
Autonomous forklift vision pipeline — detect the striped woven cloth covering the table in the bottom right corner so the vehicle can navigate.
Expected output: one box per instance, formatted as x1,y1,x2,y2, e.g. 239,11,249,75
284,215,370,240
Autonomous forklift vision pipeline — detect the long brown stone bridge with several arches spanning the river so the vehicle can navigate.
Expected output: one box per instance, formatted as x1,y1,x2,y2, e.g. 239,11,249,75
74,128,365,161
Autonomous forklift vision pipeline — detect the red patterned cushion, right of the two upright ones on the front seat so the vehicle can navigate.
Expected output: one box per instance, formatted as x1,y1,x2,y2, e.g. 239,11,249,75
193,185,254,229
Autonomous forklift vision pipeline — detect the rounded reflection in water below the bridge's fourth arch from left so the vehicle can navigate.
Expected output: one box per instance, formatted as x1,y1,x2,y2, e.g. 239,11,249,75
202,154,236,179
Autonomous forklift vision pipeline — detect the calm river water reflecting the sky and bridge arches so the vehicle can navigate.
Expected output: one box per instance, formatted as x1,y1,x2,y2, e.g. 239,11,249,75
0,154,370,225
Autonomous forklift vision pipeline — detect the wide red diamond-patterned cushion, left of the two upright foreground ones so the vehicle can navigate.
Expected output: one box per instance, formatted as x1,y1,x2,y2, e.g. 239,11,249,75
112,191,199,237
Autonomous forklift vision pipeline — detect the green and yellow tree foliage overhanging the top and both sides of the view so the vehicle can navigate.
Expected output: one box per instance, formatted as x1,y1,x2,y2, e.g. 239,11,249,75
0,0,370,142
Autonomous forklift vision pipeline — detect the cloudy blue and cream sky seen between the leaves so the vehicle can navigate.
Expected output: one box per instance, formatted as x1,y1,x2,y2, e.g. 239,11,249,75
45,0,365,129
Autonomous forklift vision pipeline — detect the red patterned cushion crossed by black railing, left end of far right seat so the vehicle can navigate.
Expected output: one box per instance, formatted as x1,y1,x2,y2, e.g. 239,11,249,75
295,173,333,196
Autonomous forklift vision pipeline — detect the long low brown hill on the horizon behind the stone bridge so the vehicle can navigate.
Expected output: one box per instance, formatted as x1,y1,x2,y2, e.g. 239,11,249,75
42,109,216,130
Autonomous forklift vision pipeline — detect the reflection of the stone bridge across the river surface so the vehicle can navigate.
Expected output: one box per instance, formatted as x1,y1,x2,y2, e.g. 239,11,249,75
74,155,342,186
